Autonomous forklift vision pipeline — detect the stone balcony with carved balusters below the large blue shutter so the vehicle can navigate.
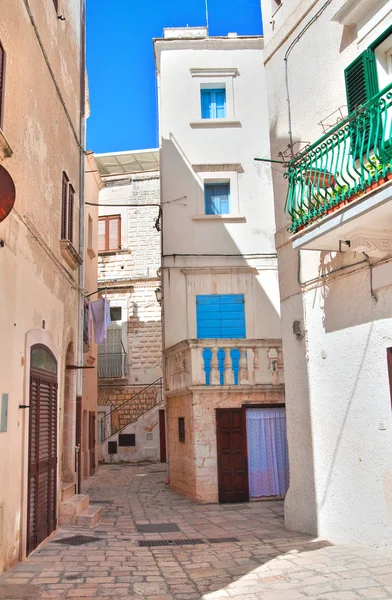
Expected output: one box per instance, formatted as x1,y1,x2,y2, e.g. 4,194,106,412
166,339,283,393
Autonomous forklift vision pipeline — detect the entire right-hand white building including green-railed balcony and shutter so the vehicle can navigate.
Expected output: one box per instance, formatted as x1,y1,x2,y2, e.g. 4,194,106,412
260,0,392,544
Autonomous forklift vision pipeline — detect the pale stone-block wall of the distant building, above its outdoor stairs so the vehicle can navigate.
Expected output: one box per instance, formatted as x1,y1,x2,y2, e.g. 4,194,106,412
98,172,162,385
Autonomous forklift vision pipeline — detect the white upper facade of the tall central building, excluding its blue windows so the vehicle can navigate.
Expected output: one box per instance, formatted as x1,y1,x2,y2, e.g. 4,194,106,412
155,33,280,348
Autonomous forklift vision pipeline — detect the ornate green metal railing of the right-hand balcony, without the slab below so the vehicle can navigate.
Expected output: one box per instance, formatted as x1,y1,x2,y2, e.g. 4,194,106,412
286,83,392,233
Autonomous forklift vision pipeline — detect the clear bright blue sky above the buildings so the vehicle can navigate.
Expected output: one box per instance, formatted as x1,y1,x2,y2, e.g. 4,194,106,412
87,0,261,152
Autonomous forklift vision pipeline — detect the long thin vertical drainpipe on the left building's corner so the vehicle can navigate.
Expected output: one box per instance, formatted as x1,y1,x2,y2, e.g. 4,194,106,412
76,0,86,478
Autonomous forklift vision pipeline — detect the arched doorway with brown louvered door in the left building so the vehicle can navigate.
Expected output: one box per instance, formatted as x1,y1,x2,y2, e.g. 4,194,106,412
27,344,57,554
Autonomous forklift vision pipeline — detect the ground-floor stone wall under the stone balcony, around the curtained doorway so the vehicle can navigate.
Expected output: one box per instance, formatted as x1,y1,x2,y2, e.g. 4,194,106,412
167,386,284,503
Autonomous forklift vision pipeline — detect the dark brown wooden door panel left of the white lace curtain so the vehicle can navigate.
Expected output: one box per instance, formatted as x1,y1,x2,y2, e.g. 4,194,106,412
216,408,249,502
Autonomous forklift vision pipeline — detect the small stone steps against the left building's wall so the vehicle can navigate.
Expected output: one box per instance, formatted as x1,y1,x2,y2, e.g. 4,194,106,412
59,483,103,527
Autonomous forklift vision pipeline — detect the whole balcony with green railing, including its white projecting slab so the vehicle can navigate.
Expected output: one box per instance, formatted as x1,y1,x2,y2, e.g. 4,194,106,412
286,84,392,256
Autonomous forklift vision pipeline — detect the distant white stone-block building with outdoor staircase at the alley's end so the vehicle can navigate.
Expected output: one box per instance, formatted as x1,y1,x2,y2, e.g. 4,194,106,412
92,149,166,462
